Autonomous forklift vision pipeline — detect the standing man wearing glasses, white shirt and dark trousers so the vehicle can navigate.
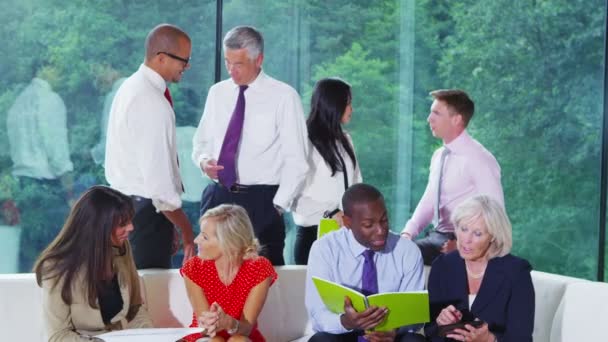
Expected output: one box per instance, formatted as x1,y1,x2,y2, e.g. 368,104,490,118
105,24,194,269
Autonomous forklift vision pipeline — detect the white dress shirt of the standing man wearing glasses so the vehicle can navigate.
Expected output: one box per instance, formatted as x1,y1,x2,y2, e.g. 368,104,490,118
105,64,182,211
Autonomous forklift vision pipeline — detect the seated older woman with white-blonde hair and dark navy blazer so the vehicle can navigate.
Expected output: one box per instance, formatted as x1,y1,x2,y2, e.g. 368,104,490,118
425,196,534,342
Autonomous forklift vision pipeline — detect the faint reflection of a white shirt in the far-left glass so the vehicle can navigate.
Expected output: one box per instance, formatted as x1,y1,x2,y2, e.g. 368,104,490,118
6,78,74,179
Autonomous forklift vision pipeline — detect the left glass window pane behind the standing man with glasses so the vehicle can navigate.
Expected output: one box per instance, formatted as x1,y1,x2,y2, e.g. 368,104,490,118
0,0,216,273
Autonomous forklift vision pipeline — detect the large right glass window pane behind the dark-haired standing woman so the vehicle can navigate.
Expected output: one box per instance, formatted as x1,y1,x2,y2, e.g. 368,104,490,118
223,0,605,278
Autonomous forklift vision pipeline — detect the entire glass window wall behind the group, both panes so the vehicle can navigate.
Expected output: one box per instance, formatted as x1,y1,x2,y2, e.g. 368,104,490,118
0,0,608,279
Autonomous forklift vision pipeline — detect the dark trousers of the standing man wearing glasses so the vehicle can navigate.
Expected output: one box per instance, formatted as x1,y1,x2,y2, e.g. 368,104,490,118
129,196,175,269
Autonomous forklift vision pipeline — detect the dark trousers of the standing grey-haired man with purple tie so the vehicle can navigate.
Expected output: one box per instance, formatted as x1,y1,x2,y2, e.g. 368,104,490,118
201,183,285,266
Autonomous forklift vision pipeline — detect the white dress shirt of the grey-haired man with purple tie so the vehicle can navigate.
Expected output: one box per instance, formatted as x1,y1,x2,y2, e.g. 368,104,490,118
192,71,308,209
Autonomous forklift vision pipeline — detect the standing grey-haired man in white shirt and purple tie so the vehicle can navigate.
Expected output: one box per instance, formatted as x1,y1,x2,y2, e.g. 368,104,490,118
192,26,308,265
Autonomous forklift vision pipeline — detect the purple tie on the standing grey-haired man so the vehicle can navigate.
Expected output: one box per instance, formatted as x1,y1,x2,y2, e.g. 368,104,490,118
217,85,248,189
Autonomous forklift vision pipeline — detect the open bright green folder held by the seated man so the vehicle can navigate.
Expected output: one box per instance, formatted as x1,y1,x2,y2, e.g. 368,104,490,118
312,277,430,331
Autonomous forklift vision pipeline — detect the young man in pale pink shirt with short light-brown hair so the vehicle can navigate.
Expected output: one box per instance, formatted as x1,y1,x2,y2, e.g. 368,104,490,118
401,89,504,265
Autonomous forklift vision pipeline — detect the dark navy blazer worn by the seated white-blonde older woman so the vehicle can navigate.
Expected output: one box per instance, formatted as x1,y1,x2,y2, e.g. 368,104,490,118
424,251,534,342
